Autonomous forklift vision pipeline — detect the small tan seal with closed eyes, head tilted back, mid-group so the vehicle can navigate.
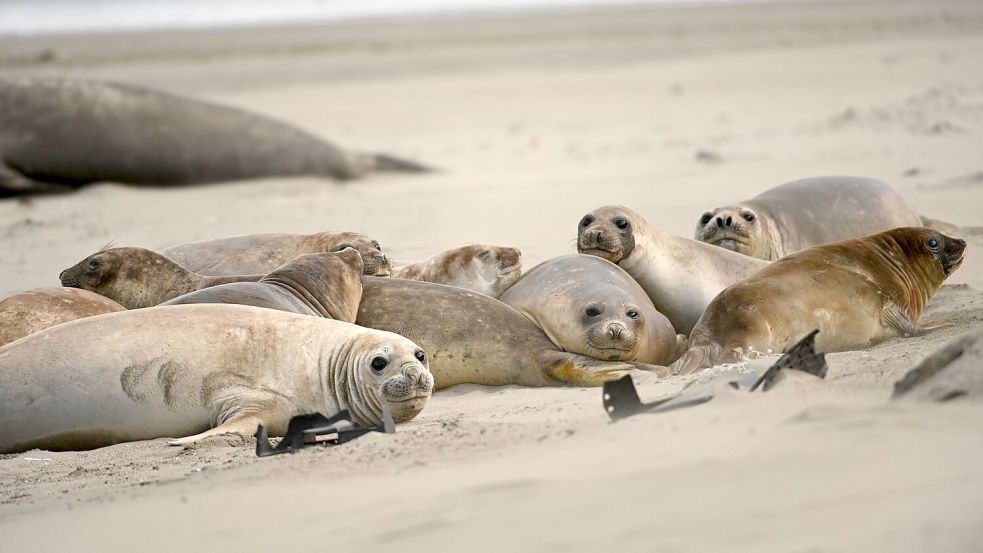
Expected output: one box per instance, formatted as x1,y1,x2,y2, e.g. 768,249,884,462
392,245,522,298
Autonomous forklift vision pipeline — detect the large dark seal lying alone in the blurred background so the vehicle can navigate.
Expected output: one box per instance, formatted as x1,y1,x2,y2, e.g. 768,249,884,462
0,78,428,195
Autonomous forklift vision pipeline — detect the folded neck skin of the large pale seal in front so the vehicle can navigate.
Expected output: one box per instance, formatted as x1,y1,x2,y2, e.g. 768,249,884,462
318,336,382,426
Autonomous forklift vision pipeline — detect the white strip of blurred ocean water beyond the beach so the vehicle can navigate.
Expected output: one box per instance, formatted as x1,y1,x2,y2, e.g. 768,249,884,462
0,0,824,34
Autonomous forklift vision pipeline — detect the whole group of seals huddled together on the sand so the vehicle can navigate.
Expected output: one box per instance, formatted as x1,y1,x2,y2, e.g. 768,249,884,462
0,76,966,453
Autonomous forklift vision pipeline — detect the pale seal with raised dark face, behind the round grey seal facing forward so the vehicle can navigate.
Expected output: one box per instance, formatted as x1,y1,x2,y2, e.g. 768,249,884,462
577,206,768,334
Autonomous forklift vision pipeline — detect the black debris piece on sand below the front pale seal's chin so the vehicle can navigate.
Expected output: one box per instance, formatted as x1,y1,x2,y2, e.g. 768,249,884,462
256,405,396,457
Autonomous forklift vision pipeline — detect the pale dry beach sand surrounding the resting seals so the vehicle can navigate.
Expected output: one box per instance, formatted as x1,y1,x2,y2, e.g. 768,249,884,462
0,2,983,552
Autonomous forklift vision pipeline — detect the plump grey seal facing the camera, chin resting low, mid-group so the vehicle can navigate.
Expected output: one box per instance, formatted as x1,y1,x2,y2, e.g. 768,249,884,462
500,255,686,365
